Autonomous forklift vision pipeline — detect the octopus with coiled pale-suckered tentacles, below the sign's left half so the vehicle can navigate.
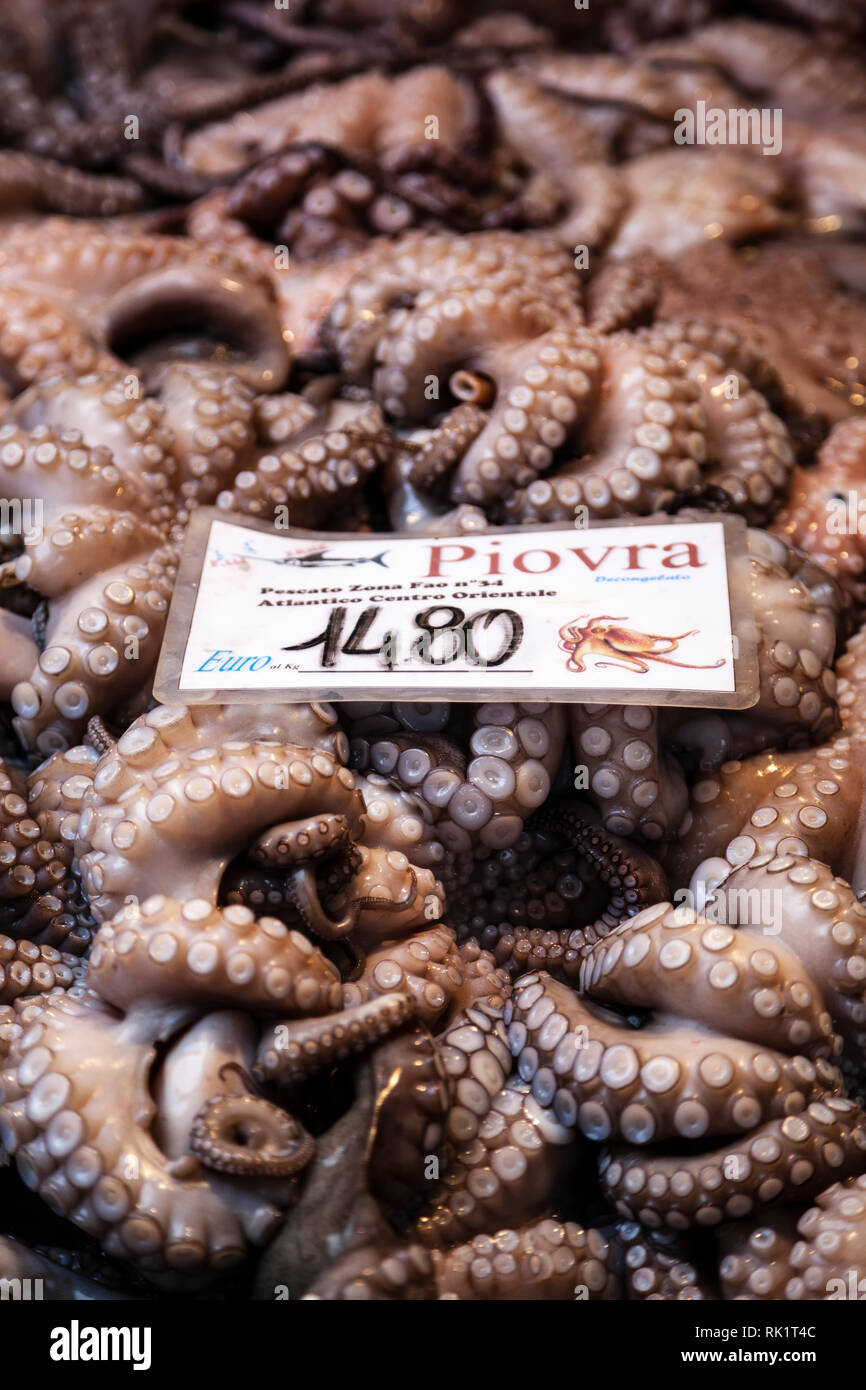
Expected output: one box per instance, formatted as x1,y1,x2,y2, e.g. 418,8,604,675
0,710,461,1282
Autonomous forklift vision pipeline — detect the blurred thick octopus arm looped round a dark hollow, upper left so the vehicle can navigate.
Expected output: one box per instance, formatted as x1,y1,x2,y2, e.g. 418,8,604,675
0,218,289,392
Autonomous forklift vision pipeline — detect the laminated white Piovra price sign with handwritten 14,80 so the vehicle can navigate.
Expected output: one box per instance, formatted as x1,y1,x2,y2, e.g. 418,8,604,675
156,507,758,709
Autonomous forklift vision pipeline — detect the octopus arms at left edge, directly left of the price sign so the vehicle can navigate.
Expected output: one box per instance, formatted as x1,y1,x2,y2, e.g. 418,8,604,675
0,411,177,753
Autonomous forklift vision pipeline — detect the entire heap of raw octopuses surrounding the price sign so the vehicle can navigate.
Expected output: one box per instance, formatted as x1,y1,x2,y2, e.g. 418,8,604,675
0,0,866,1301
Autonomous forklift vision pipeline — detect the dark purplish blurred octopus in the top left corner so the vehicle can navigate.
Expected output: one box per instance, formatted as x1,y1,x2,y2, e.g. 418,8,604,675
0,0,397,215
